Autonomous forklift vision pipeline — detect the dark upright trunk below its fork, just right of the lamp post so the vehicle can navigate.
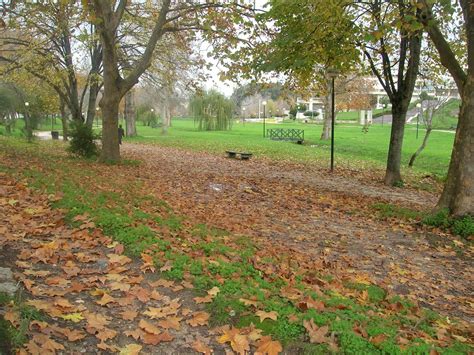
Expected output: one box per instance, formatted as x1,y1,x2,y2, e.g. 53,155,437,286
384,100,409,186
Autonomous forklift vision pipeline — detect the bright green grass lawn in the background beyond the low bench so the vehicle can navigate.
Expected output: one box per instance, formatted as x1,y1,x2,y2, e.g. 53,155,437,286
129,119,454,177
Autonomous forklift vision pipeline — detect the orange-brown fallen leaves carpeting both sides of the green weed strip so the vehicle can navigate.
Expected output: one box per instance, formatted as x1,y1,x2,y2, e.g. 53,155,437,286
0,140,474,354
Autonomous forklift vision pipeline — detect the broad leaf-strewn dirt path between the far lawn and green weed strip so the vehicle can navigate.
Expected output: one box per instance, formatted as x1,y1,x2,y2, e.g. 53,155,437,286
123,144,474,322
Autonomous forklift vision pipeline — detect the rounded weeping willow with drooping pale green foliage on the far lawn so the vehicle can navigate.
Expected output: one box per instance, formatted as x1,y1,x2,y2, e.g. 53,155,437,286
189,90,234,131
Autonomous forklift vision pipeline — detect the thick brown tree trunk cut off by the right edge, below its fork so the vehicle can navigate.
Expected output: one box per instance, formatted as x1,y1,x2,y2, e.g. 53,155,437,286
438,78,474,216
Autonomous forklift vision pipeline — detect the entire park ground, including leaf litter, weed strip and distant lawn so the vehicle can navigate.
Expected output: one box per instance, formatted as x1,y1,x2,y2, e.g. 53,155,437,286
0,120,474,354
